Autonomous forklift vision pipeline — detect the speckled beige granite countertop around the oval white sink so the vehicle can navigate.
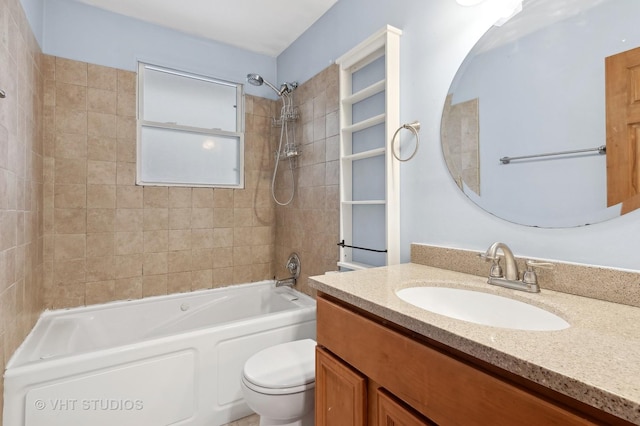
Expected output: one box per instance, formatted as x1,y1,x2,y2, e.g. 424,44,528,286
309,263,640,424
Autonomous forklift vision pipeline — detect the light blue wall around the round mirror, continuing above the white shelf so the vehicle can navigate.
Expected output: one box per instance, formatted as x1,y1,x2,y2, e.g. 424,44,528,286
278,0,640,270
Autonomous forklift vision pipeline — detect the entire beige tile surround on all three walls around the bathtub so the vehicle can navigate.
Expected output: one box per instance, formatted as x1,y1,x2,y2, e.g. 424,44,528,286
0,0,339,416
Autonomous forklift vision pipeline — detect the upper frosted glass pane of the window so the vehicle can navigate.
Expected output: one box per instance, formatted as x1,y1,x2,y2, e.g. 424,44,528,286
142,67,238,132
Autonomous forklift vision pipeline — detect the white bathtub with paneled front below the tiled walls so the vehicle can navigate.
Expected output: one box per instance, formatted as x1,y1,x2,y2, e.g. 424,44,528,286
3,281,316,426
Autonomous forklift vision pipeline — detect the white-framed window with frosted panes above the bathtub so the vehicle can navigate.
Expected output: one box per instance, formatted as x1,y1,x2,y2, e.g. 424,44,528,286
137,63,244,188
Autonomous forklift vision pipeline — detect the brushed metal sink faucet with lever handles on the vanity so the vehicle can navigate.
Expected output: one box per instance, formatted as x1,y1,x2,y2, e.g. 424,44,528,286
479,242,553,293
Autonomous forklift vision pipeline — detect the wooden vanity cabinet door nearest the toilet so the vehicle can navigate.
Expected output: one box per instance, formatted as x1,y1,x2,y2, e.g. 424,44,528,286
315,347,367,426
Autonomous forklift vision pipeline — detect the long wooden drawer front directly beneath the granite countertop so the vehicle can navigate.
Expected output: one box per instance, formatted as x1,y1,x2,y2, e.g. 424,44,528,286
317,297,593,426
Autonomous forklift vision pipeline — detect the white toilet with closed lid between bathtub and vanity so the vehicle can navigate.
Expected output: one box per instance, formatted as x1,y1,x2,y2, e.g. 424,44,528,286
241,339,316,426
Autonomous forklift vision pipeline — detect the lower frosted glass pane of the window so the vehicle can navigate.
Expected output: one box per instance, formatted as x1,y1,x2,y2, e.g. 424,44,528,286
140,126,242,185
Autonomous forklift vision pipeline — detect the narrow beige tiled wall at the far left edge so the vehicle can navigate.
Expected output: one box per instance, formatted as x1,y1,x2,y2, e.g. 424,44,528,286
0,0,43,416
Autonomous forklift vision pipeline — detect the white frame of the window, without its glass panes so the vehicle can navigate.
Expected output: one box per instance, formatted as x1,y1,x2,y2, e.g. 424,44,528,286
136,62,244,189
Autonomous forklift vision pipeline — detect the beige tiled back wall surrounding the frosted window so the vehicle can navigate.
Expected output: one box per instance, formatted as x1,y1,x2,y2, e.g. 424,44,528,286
44,56,275,308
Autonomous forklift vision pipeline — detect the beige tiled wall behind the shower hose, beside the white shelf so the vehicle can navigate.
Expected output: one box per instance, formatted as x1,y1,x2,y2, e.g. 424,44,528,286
271,65,340,294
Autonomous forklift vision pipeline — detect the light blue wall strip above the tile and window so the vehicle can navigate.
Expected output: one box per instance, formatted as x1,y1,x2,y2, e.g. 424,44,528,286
38,0,276,97
